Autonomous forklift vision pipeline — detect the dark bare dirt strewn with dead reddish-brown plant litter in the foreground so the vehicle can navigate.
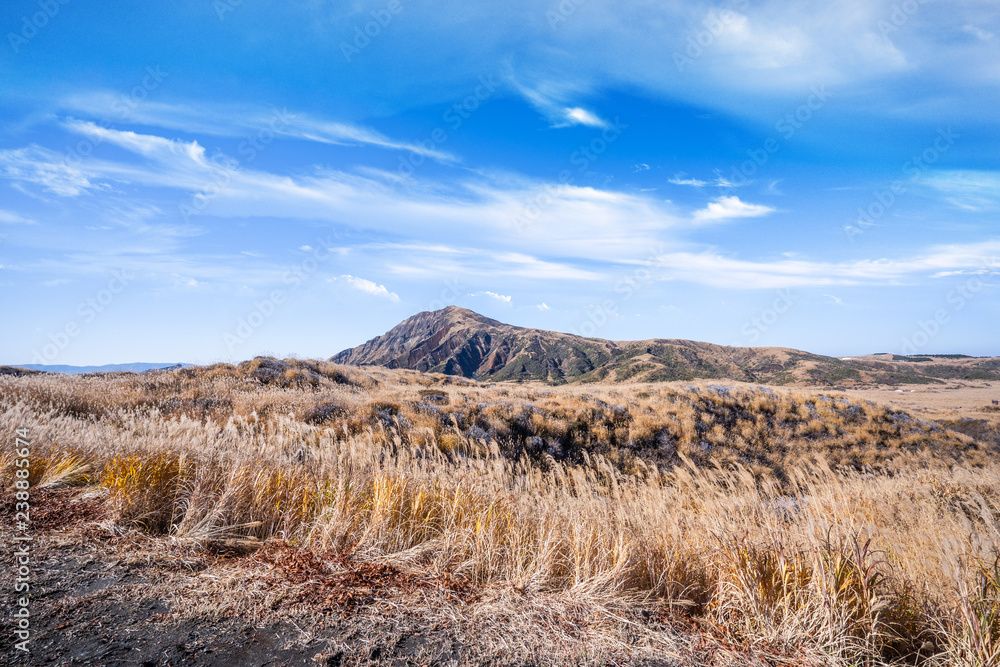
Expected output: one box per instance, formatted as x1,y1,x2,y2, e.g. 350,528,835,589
0,489,792,667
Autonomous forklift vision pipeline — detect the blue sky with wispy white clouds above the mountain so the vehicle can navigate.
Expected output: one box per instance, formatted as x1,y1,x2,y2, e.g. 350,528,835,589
0,0,1000,364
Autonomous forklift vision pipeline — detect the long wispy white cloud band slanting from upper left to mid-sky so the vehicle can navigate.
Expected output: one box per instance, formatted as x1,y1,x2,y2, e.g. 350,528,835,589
25,123,684,264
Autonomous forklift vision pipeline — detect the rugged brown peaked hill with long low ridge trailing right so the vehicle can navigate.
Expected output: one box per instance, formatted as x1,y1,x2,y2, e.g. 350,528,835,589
330,306,1000,386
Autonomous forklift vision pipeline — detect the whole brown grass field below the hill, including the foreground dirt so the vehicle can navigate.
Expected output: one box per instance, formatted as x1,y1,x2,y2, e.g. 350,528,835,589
0,358,1000,667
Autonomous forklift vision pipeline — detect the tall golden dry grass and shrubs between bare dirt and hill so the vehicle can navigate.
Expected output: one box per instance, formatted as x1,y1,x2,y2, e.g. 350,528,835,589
0,359,1000,665
